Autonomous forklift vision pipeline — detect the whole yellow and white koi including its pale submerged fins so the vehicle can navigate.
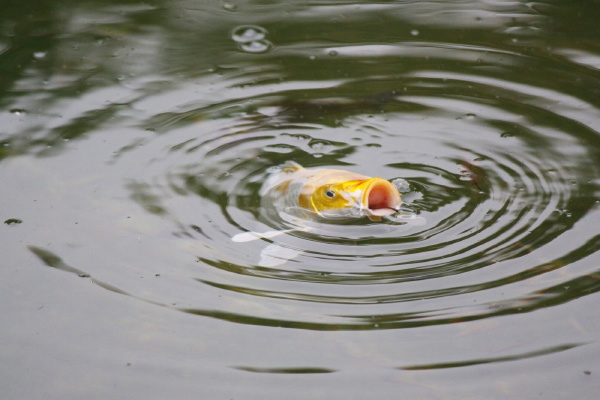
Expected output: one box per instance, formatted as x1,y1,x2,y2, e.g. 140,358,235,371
231,161,414,267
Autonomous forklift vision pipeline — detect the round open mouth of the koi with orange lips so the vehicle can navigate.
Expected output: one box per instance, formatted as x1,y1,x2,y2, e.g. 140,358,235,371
361,178,402,217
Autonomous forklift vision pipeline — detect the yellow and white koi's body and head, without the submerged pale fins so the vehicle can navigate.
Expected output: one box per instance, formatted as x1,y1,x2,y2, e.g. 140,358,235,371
260,161,402,222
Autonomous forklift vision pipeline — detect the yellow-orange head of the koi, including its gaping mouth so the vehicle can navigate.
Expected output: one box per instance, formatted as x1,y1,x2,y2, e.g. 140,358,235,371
301,178,402,221
